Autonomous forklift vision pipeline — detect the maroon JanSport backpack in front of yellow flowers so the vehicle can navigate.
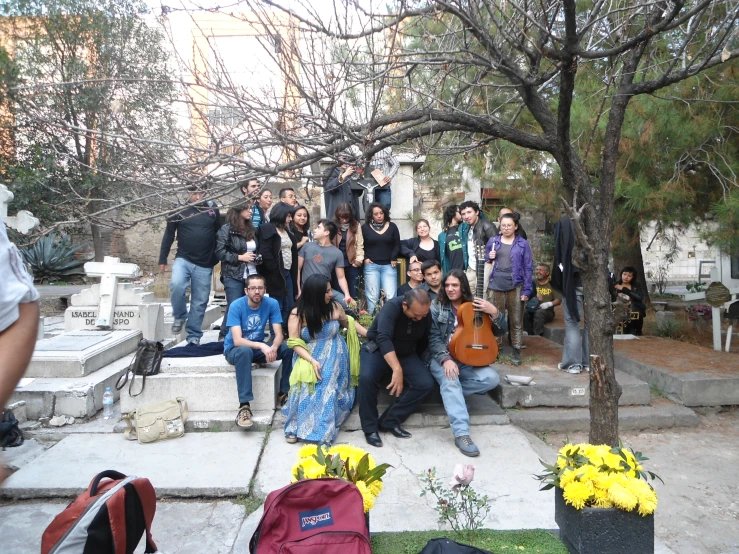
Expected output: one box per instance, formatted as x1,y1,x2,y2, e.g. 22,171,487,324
249,479,372,554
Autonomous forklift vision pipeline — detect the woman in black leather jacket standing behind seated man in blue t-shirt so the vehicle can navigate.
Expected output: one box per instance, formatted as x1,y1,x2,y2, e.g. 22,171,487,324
216,200,258,341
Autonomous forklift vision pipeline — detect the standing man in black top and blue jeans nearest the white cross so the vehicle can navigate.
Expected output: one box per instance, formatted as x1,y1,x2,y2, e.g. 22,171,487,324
159,188,221,345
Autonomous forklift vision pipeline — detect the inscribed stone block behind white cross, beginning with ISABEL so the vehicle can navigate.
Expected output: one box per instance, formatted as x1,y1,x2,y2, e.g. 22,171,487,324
64,283,165,340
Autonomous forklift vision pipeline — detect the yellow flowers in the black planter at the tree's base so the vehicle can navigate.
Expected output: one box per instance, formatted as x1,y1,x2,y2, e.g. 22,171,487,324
536,444,661,516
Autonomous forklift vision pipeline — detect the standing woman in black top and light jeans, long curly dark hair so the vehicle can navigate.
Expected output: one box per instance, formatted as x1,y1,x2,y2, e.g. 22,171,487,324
362,202,400,314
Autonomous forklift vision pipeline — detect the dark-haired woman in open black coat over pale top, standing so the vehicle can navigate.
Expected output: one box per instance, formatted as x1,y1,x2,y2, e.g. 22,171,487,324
257,202,298,326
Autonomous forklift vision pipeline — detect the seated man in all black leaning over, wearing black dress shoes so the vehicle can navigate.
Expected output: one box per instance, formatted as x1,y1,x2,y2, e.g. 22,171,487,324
359,288,434,447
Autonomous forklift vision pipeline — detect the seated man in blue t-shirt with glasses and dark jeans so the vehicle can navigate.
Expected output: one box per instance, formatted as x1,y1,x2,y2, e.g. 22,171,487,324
223,275,293,428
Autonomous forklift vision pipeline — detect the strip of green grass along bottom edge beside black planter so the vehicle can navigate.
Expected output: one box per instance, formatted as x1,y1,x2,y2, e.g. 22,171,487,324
371,529,568,554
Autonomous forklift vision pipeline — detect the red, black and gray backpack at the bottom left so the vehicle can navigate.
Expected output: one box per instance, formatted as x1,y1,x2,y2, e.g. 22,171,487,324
41,470,157,554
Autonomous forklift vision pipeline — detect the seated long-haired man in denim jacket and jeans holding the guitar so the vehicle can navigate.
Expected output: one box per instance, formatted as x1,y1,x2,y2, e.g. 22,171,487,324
429,269,504,456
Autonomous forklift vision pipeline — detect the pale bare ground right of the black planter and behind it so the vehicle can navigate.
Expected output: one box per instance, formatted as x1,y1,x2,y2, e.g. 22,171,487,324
540,407,739,554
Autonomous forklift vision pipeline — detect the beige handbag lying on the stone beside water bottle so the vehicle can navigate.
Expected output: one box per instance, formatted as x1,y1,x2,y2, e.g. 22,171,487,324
121,396,188,444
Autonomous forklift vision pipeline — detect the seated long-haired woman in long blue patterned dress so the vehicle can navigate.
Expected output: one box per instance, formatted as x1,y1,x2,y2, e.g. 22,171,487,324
282,274,367,443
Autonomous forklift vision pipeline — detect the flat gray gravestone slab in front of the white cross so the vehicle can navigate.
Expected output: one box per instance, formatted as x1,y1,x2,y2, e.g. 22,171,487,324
26,330,141,377
